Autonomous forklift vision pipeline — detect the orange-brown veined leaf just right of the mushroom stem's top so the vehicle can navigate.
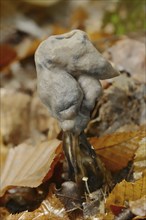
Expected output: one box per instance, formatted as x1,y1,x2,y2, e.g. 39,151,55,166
90,126,146,172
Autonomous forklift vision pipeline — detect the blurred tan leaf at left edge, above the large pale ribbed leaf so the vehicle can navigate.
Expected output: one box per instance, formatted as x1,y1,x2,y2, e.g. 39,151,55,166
0,89,31,145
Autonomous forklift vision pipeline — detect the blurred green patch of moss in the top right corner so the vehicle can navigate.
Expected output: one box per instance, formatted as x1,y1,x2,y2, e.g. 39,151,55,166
103,0,146,35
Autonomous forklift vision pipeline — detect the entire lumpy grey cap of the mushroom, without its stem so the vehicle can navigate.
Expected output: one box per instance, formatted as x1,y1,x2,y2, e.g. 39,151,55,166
35,30,119,134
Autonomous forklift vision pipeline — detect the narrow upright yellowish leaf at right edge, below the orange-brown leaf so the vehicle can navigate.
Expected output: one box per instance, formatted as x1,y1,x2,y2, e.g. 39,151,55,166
133,137,146,180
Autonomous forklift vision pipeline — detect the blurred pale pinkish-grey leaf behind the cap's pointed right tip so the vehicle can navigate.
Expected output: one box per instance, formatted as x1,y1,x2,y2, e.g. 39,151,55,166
103,38,146,82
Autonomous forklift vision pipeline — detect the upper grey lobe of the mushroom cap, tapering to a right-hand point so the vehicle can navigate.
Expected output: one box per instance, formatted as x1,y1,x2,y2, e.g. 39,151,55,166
35,30,119,80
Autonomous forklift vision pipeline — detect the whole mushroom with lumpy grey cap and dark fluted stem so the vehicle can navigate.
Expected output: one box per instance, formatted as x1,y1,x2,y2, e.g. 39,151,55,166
35,30,119,191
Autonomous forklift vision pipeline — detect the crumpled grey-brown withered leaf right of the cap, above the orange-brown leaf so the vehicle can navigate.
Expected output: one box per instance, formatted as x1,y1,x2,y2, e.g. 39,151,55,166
87,73,146,137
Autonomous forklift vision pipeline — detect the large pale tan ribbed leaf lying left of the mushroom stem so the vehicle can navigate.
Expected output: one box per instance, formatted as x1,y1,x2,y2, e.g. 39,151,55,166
0,139,61,196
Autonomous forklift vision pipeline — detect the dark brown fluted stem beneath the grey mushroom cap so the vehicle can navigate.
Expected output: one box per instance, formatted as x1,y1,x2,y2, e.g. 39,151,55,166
63,132,109,192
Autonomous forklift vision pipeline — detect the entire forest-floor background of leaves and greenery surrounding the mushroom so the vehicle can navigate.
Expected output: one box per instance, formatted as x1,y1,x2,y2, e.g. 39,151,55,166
0,0,146,220
